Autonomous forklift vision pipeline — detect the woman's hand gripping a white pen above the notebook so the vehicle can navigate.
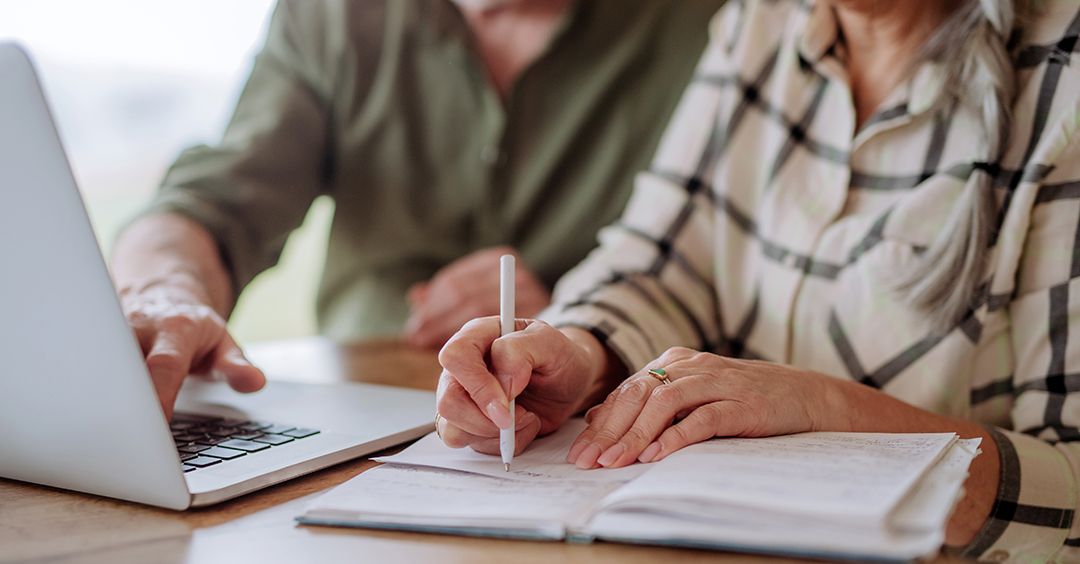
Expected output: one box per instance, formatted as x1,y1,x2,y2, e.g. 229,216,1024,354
437,317,605,454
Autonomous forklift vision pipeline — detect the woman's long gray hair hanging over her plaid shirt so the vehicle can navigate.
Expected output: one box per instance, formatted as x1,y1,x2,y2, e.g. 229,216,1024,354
897,0,1029,331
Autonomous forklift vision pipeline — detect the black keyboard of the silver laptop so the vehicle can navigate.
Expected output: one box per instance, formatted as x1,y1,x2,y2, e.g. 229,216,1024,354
168,413,319,472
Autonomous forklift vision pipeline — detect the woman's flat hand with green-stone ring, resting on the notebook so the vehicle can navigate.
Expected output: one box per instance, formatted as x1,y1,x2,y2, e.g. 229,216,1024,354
567,348,843,468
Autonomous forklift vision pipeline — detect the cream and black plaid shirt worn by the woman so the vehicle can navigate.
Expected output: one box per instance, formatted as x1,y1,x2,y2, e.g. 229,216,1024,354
543,0,1080,561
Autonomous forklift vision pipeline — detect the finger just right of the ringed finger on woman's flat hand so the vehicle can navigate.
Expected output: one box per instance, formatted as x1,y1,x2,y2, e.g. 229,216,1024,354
596,376,716,468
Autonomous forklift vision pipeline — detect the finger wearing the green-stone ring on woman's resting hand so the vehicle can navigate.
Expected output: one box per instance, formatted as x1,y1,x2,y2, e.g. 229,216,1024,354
573,375,660,468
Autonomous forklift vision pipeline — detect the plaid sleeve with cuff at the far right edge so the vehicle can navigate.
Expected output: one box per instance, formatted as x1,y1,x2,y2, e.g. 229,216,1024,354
967,108,1080,562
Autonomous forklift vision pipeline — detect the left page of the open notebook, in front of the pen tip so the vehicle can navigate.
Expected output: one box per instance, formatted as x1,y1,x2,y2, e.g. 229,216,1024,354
299,465,618,538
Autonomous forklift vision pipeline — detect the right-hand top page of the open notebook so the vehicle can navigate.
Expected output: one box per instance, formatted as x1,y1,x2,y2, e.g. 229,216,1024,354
607,433,956,522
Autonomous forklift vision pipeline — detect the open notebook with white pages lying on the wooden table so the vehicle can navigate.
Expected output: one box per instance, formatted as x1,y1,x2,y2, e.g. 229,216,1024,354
298,419,978,560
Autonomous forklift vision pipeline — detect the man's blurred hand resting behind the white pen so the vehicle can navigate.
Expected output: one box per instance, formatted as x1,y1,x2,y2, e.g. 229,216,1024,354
405,246,551,349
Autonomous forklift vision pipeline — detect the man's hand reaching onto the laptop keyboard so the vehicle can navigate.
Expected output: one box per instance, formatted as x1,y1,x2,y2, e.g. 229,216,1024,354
120,282,266,418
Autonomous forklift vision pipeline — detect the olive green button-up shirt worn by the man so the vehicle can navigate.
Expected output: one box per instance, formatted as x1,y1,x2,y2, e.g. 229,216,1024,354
147,0,723,338
